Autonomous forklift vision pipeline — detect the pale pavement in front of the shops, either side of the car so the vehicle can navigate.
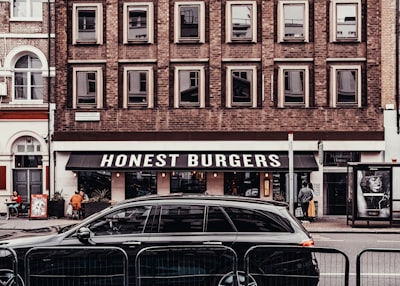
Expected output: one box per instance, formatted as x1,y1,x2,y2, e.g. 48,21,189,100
0,216,400,234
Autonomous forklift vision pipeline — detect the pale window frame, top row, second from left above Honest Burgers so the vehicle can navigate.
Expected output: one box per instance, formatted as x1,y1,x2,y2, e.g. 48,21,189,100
123,2,154,44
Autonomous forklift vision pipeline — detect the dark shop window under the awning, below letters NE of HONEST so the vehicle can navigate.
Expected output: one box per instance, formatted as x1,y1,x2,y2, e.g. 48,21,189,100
125,172,157,199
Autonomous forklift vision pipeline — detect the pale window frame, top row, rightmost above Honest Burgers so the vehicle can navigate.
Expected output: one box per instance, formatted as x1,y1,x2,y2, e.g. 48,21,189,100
330,0,362,42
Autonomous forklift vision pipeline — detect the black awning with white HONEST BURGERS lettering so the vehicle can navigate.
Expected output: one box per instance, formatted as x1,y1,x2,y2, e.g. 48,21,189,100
66,151,318,172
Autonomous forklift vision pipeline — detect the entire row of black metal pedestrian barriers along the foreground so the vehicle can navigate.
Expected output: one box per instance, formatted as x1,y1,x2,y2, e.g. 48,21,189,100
0,245,400,286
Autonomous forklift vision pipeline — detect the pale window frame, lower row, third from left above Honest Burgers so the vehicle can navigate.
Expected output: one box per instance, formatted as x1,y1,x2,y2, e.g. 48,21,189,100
174,66,206,108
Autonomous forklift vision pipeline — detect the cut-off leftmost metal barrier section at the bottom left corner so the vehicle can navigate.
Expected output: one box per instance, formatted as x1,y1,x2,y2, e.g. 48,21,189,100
0,248,19,286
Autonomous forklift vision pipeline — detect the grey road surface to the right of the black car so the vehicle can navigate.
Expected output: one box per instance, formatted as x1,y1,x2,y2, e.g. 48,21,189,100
313,233,400,286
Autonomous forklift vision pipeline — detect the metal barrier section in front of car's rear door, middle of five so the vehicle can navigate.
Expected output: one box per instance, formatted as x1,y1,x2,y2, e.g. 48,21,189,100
135,245,237,286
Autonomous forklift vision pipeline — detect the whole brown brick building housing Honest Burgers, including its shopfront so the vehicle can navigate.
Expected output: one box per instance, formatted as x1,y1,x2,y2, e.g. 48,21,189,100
50,0,385,216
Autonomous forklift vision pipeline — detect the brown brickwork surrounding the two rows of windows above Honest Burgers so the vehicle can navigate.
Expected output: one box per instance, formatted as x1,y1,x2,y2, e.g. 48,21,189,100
55,0,383,136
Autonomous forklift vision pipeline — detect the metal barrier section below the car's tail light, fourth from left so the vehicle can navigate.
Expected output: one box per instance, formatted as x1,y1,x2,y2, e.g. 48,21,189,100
245,245,349,286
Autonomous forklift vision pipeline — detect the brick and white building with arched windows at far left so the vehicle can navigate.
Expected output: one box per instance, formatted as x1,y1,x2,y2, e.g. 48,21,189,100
0,0,55,213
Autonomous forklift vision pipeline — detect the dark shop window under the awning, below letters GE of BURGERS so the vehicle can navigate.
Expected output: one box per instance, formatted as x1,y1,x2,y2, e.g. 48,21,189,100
224,172,260,198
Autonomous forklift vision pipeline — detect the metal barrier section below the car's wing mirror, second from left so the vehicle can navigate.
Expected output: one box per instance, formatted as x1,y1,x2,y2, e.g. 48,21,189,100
25,247,128,286
